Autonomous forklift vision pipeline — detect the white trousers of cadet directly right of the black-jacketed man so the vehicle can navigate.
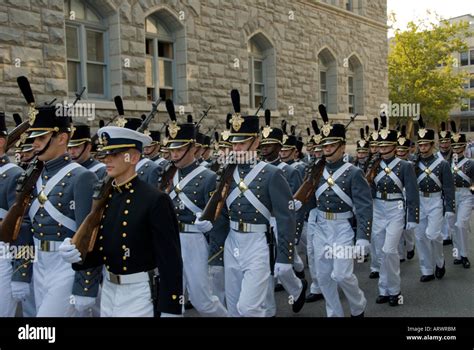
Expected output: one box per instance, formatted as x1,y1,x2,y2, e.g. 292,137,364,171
179,233,227,317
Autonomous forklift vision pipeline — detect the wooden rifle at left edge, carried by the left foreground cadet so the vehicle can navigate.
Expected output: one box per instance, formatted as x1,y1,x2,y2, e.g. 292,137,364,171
0,156,44,243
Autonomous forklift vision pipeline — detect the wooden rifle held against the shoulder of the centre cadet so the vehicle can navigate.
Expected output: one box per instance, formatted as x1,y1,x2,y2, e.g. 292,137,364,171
200,164,236,222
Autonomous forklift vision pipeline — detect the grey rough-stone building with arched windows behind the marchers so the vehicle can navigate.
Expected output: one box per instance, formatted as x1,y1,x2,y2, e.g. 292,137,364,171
0,0,388,145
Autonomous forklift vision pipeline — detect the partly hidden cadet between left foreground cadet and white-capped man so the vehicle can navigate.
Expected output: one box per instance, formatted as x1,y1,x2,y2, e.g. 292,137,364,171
68,123,105,179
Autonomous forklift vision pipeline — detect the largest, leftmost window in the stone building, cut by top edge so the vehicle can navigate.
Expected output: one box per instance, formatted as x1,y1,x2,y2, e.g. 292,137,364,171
64,0,107,98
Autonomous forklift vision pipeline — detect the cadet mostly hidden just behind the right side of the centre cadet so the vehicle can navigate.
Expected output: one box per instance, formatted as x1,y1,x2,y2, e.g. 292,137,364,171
260,109,306,311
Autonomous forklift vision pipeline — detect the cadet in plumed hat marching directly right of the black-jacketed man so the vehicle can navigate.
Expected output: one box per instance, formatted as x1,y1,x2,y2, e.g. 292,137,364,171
166,100,229,317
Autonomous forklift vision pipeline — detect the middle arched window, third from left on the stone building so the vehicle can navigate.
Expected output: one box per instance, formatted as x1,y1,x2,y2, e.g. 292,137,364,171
248,33,277,109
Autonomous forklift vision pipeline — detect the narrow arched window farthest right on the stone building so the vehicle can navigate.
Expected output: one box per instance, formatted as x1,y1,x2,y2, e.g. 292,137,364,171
347,55,364,114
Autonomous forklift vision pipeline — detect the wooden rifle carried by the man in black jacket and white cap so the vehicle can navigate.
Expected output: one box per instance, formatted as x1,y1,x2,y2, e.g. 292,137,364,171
71,176,113,263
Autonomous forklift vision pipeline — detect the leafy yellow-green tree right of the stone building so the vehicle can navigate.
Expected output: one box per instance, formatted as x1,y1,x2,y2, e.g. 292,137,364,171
388,13,474,129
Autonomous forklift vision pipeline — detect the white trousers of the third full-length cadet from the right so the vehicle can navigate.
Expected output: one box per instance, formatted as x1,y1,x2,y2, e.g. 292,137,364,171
371,199,405,296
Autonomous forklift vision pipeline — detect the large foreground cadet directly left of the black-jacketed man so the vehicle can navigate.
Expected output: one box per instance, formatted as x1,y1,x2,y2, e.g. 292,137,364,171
12,100,100,317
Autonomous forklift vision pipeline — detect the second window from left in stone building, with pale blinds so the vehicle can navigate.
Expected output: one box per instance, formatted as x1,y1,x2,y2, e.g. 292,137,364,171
145,17,176,101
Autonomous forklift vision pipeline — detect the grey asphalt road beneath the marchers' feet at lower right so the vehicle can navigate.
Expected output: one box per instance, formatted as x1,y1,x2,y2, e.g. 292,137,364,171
186,215,474,317
